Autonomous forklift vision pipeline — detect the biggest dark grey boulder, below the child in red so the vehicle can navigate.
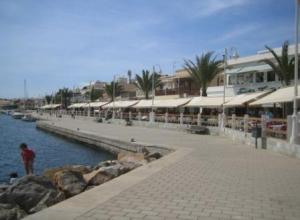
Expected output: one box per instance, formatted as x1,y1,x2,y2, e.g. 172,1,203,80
0,175,65,213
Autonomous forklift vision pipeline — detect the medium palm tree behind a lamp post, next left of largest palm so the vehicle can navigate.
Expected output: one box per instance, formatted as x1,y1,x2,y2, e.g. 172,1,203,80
134,70,161,99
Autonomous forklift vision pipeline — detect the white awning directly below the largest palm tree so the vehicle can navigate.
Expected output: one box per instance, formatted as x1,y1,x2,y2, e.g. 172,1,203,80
185,96,232,108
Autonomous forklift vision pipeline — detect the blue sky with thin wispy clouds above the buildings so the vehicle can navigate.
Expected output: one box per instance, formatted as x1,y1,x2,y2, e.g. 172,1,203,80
0,0,295,98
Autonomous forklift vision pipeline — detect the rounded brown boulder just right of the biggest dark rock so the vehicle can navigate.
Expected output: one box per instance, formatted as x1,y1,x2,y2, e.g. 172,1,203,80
54,170,86,198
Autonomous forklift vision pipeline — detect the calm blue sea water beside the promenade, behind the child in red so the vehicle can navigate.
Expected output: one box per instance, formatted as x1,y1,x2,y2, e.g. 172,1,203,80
0,114,114,183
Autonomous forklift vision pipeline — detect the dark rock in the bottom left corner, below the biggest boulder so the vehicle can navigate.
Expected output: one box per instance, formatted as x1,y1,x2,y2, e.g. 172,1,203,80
0,203,27,220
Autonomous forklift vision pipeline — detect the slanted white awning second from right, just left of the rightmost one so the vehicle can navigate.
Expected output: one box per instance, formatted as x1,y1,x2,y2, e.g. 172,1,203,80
224,91,270,107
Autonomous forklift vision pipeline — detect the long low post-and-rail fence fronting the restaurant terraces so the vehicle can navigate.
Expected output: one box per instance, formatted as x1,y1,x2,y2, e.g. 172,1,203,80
40,110,287,140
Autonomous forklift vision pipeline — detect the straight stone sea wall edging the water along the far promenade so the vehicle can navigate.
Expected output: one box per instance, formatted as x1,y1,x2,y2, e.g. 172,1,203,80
36,121,171,155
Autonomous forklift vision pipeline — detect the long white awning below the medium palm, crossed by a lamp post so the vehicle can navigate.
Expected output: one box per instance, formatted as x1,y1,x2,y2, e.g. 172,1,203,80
133,98,191,108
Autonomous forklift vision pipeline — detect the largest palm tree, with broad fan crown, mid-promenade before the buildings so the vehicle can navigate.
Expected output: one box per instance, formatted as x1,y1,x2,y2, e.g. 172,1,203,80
184,52,222,96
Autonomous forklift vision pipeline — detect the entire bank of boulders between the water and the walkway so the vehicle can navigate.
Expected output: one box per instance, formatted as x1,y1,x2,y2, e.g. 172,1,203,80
0,152,162,220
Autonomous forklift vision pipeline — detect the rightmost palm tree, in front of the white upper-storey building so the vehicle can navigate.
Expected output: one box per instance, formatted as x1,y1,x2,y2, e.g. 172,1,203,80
262,41,295,86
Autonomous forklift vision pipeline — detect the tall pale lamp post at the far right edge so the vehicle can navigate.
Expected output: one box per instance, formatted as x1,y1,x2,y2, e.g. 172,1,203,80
290,0,300,144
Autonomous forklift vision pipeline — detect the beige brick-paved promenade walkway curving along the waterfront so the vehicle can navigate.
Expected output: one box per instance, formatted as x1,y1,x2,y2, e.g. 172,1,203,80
29,116,300,220
